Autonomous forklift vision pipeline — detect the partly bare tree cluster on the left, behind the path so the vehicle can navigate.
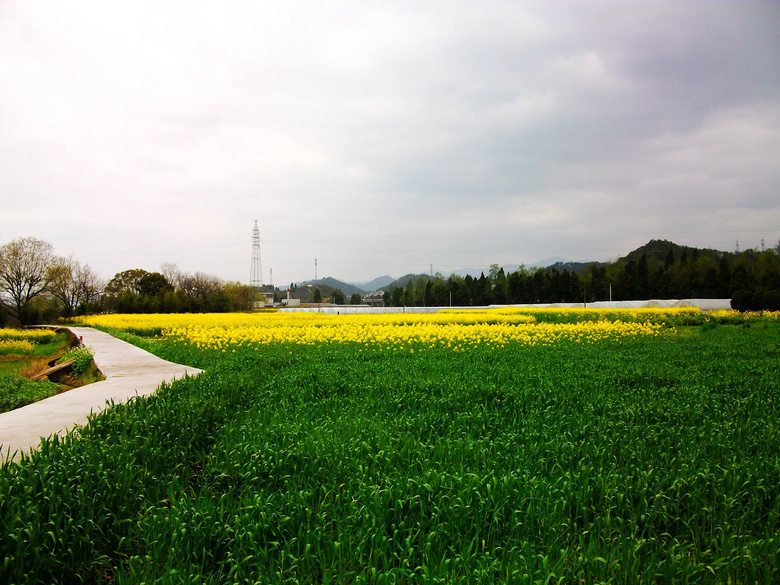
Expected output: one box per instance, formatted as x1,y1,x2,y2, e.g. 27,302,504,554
0,237,258,326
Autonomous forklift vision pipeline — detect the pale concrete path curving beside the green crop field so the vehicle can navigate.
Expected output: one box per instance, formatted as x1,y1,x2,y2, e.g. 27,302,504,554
0,327,203,461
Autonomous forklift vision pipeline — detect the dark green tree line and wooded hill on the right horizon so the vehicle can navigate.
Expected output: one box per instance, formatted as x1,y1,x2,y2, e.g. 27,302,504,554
384,241,780,310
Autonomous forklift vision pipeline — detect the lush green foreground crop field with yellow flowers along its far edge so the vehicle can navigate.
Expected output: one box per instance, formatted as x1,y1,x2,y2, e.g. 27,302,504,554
0,314,780,583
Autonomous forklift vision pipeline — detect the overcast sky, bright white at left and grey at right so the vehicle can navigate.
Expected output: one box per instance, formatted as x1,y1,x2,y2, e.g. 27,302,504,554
0,0,780,287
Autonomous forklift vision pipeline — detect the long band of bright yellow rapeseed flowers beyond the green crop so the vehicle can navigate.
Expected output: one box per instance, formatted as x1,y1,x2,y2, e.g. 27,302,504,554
76,309,663,351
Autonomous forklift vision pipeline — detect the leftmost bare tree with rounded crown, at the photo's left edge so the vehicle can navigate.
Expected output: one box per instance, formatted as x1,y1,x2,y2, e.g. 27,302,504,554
0,237,54,325
